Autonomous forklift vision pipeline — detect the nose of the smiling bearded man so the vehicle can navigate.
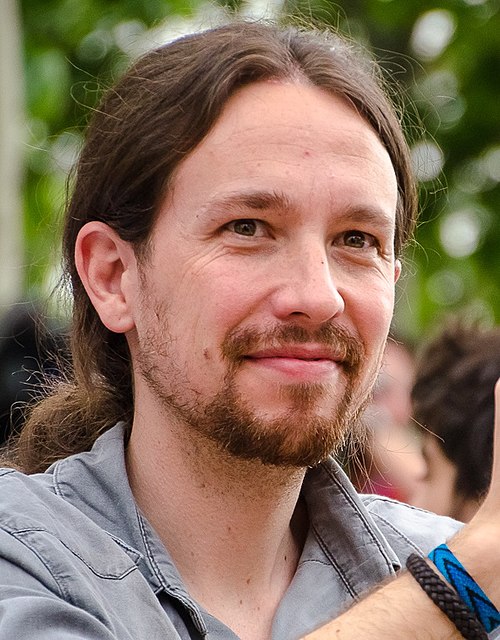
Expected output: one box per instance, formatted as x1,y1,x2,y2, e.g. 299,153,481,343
273,247,345,325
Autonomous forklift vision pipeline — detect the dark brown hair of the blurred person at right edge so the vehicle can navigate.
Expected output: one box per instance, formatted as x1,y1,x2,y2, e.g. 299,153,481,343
412,321,500,508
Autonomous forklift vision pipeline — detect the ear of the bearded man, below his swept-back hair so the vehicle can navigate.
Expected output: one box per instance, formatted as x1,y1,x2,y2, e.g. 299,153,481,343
75,221,137,333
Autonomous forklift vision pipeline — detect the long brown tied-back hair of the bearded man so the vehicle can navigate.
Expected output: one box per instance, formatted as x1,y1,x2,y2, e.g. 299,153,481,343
6,22,417,472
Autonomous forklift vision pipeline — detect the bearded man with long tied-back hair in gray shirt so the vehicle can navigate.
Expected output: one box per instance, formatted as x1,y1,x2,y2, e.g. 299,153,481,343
0,24,500,640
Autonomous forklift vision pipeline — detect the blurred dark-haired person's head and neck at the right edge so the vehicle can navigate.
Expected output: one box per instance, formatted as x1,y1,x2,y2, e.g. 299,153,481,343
410,321,500,522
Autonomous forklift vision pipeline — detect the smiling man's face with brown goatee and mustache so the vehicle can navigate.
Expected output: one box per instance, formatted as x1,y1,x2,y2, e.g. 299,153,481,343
128,82,398,466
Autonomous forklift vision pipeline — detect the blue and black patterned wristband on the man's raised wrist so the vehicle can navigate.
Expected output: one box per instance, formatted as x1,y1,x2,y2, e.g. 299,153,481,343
429,544,500,633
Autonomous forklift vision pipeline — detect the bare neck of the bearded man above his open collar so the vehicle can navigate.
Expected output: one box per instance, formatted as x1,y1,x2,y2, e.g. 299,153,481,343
127,404,306,638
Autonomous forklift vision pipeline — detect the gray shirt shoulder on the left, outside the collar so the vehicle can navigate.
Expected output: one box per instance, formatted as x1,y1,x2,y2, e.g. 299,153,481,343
0,469,178,640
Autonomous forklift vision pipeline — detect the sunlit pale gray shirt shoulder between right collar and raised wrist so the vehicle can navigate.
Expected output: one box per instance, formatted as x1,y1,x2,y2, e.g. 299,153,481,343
360,495,463,561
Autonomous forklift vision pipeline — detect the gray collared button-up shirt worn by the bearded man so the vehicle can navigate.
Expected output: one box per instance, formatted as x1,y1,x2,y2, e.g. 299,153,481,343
0,424,468,640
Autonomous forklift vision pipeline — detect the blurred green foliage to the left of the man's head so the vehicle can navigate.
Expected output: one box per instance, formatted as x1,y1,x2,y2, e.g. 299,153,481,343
20,0,208,298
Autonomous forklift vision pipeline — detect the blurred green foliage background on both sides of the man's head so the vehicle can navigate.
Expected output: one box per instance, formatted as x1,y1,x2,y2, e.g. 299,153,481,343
21,0,500,338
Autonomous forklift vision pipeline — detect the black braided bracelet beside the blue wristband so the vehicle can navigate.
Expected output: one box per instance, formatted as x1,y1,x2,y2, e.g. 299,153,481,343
406,553,488,640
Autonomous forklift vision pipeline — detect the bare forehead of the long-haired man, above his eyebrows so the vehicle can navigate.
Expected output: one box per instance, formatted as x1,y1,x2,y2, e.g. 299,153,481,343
164,81,397,220
